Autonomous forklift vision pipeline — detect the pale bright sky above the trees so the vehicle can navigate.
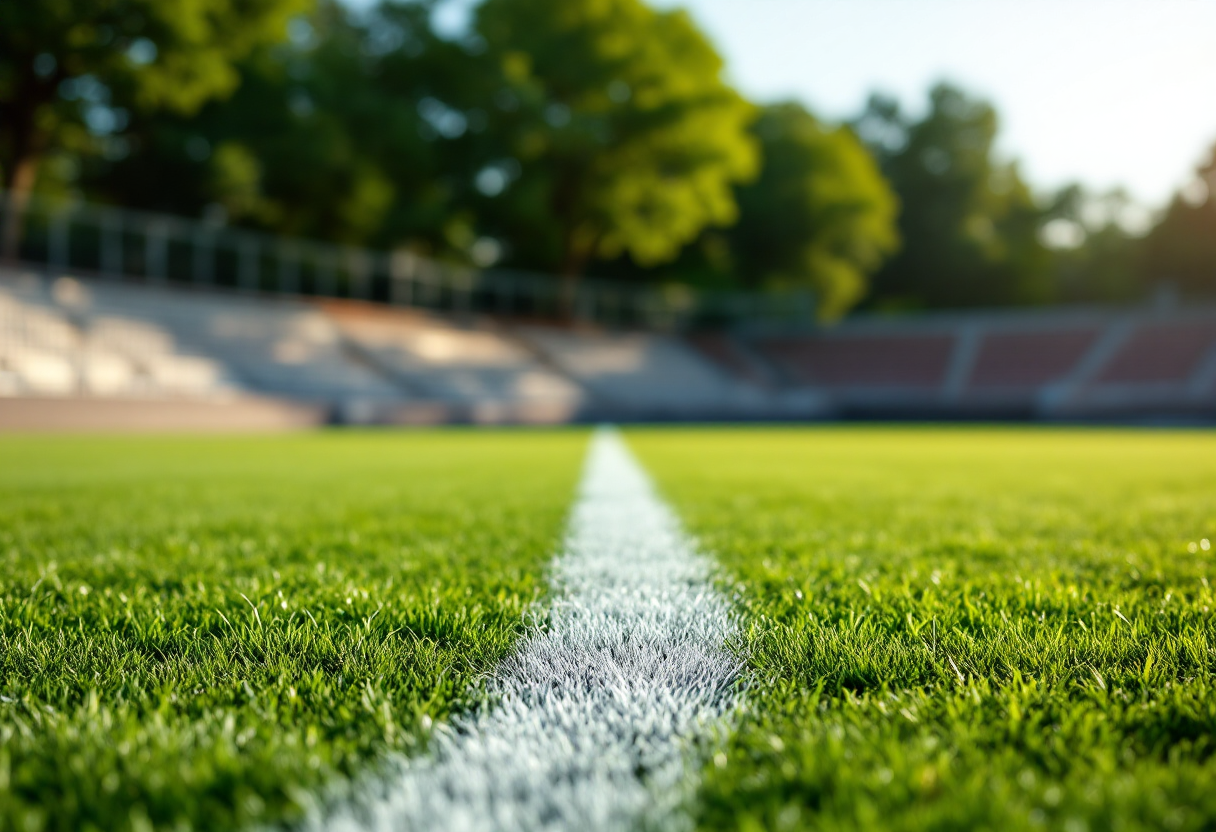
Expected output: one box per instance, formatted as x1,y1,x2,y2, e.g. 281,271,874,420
415,0,1216,207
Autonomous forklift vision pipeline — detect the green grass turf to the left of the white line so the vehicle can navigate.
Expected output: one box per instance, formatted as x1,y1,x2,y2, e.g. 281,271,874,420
0,432,586,832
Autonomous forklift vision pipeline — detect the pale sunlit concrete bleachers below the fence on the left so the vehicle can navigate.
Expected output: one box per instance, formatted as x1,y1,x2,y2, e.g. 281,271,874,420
0,272,783,425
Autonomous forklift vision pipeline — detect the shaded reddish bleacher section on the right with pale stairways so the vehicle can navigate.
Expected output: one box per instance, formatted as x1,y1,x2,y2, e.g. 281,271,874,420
719,309,1216,420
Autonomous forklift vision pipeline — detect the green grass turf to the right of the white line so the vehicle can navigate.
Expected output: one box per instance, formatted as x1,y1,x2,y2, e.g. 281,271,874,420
629,428,1216,832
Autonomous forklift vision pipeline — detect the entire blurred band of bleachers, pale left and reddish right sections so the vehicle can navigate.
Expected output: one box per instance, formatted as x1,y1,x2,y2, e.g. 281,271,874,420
0,265,1216,428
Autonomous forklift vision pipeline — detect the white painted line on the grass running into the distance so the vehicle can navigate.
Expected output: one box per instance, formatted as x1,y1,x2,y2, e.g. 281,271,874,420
304,429,739,832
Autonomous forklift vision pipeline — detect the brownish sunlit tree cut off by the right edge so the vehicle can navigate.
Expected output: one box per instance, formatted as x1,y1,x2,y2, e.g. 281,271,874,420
1141,147,1216,297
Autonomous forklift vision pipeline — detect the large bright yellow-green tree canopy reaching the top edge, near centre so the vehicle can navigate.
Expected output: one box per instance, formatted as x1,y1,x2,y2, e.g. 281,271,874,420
475,0,756,285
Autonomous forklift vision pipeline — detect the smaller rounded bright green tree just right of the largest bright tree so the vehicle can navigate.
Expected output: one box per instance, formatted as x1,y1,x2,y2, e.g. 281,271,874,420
727,103,899,320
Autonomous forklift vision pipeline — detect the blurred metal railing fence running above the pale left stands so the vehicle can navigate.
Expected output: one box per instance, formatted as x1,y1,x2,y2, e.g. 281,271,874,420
0,195,814,330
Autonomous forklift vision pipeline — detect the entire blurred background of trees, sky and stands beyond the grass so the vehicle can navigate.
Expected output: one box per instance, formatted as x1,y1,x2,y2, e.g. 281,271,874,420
0,0,1216,428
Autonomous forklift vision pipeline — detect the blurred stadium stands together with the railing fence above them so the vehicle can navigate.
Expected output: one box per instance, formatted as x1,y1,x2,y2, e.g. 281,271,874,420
0,197,1216,429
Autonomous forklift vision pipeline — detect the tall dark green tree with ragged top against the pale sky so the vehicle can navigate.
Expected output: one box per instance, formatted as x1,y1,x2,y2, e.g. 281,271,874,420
855,84,1052,308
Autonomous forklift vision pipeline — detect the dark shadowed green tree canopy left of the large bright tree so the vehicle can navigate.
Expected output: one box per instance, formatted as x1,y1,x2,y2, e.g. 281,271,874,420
90,1,484,252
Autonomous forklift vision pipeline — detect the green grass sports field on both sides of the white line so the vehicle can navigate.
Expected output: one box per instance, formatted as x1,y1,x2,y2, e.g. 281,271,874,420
0,427,1216,832
